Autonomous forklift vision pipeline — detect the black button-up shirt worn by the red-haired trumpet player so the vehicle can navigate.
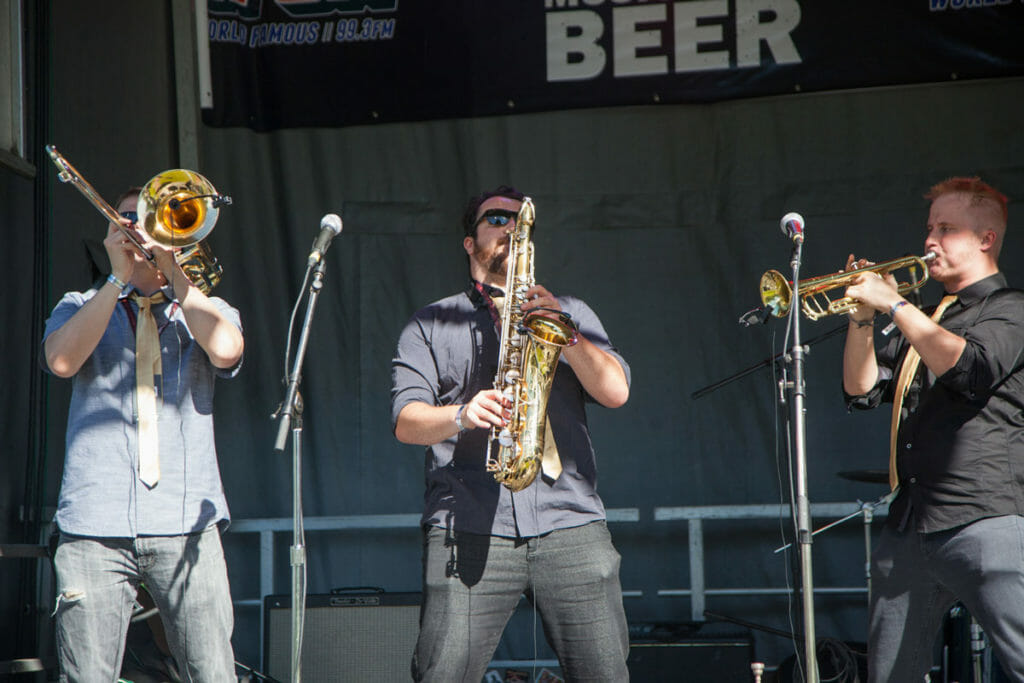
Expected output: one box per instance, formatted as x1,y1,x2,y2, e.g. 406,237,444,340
847,273,1024,532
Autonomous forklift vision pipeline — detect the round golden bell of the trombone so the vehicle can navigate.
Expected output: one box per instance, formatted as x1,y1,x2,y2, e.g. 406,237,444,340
137,168,219,247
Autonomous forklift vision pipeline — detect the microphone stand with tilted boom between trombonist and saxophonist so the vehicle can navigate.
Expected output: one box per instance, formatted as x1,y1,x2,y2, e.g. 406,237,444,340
272,258,326,683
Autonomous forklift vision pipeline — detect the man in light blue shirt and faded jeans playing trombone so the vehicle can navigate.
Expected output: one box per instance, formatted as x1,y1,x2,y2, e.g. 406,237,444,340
42,188,244,683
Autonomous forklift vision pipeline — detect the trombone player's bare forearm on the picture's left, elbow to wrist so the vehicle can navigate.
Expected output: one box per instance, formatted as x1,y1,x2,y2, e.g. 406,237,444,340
43,283,120,377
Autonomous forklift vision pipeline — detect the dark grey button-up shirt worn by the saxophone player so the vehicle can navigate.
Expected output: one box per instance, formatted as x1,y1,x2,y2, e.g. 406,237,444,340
391,287,630,538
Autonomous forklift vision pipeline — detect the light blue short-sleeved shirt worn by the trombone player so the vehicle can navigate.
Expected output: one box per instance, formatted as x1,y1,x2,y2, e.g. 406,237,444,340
42,290,242,538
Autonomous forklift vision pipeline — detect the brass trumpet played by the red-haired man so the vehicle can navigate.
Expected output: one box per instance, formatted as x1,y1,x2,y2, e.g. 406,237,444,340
761,252,935,321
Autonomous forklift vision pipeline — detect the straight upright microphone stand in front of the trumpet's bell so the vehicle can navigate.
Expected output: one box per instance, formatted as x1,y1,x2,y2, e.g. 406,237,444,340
779,233,818,683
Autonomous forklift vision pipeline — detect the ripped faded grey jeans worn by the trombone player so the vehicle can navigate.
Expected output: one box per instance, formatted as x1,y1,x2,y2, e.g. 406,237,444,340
54,526,238,683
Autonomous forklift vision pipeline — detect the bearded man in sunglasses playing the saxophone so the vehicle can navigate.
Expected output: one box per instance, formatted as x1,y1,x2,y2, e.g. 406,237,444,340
391,185,630,683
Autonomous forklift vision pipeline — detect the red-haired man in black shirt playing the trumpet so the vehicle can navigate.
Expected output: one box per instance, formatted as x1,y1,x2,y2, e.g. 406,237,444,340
843,177,1024,683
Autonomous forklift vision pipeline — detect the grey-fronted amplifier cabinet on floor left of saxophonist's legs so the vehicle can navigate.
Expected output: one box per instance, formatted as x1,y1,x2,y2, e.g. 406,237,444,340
263,593,421,683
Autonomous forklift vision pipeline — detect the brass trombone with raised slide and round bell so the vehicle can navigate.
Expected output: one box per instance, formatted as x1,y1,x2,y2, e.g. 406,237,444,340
46,144,231,294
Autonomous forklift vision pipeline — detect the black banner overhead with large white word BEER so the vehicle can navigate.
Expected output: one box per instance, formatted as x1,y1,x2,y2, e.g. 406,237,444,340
203,0,1024,130
